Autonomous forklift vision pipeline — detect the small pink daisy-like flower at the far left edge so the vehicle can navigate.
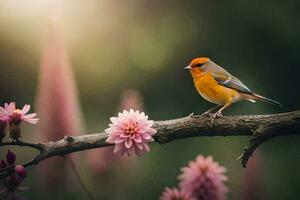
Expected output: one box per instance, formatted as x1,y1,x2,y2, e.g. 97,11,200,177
0,102,39,125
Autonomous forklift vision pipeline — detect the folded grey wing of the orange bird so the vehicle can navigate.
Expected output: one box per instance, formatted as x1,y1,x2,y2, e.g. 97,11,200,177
211,73,253,94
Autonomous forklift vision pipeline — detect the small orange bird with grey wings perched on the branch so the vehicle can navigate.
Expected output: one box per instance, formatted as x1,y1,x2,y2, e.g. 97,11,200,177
184,57,282,127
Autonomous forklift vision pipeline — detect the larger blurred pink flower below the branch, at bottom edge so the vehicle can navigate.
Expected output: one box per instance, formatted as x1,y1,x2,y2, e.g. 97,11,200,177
179,155,228,200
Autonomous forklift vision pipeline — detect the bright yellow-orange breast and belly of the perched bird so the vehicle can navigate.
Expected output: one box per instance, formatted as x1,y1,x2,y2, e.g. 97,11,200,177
192,72,240,105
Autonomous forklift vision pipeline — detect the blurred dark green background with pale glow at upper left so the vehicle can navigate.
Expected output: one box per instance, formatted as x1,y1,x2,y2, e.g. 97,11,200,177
0,0,300,200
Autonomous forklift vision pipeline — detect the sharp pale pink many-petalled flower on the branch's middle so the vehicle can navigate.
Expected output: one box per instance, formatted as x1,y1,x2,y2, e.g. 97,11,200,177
105,109,156,155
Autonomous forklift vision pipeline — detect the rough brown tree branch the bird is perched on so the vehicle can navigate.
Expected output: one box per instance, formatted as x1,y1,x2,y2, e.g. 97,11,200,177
0,110,300,175
